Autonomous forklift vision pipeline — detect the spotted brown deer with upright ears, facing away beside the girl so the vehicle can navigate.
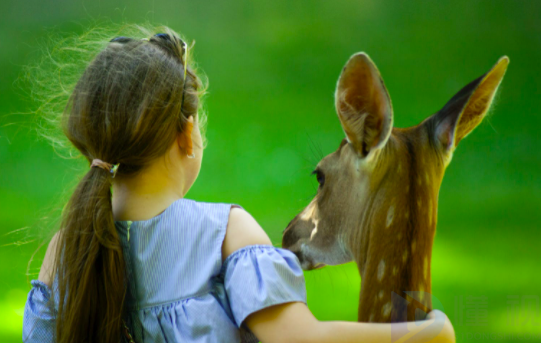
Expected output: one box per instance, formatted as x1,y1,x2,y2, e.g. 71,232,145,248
282,52,509,323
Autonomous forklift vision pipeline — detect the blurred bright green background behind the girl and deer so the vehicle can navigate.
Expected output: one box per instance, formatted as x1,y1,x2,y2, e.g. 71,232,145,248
0,0,541,342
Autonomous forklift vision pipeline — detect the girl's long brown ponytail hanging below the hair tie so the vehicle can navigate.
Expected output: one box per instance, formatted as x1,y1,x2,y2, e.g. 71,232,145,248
56,168,126,343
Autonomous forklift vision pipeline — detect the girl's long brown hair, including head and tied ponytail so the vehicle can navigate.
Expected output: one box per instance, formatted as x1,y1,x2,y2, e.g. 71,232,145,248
48,27,202,343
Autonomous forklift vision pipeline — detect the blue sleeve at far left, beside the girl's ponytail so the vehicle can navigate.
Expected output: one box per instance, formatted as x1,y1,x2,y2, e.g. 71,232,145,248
23,280,56,343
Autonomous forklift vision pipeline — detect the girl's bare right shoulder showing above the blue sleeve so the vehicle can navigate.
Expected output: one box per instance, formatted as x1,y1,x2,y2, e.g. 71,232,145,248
222,207,272,260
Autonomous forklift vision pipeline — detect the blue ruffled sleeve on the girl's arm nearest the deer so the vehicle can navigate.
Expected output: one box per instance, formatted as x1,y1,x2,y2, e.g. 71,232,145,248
221,245,306,327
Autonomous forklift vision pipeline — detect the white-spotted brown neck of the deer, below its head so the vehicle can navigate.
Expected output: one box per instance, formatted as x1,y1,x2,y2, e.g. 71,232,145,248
354,150,441,322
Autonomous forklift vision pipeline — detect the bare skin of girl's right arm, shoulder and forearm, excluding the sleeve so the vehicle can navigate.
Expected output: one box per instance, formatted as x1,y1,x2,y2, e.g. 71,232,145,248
222,208,455,343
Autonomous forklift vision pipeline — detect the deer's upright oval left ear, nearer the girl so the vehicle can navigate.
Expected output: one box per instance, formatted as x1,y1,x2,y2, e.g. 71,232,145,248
335,53,393,157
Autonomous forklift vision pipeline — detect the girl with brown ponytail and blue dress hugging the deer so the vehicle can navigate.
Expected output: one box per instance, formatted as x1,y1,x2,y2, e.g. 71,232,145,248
23,24,454,343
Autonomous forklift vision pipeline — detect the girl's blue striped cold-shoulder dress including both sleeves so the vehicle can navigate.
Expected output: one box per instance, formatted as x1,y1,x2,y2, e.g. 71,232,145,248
23,198,306,343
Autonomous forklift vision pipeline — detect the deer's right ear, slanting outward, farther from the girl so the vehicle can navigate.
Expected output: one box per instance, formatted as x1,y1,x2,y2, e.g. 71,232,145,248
428,56,509,151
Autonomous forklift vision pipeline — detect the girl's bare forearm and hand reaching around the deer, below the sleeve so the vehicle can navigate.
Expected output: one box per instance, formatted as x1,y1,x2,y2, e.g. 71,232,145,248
245,302,456,343
